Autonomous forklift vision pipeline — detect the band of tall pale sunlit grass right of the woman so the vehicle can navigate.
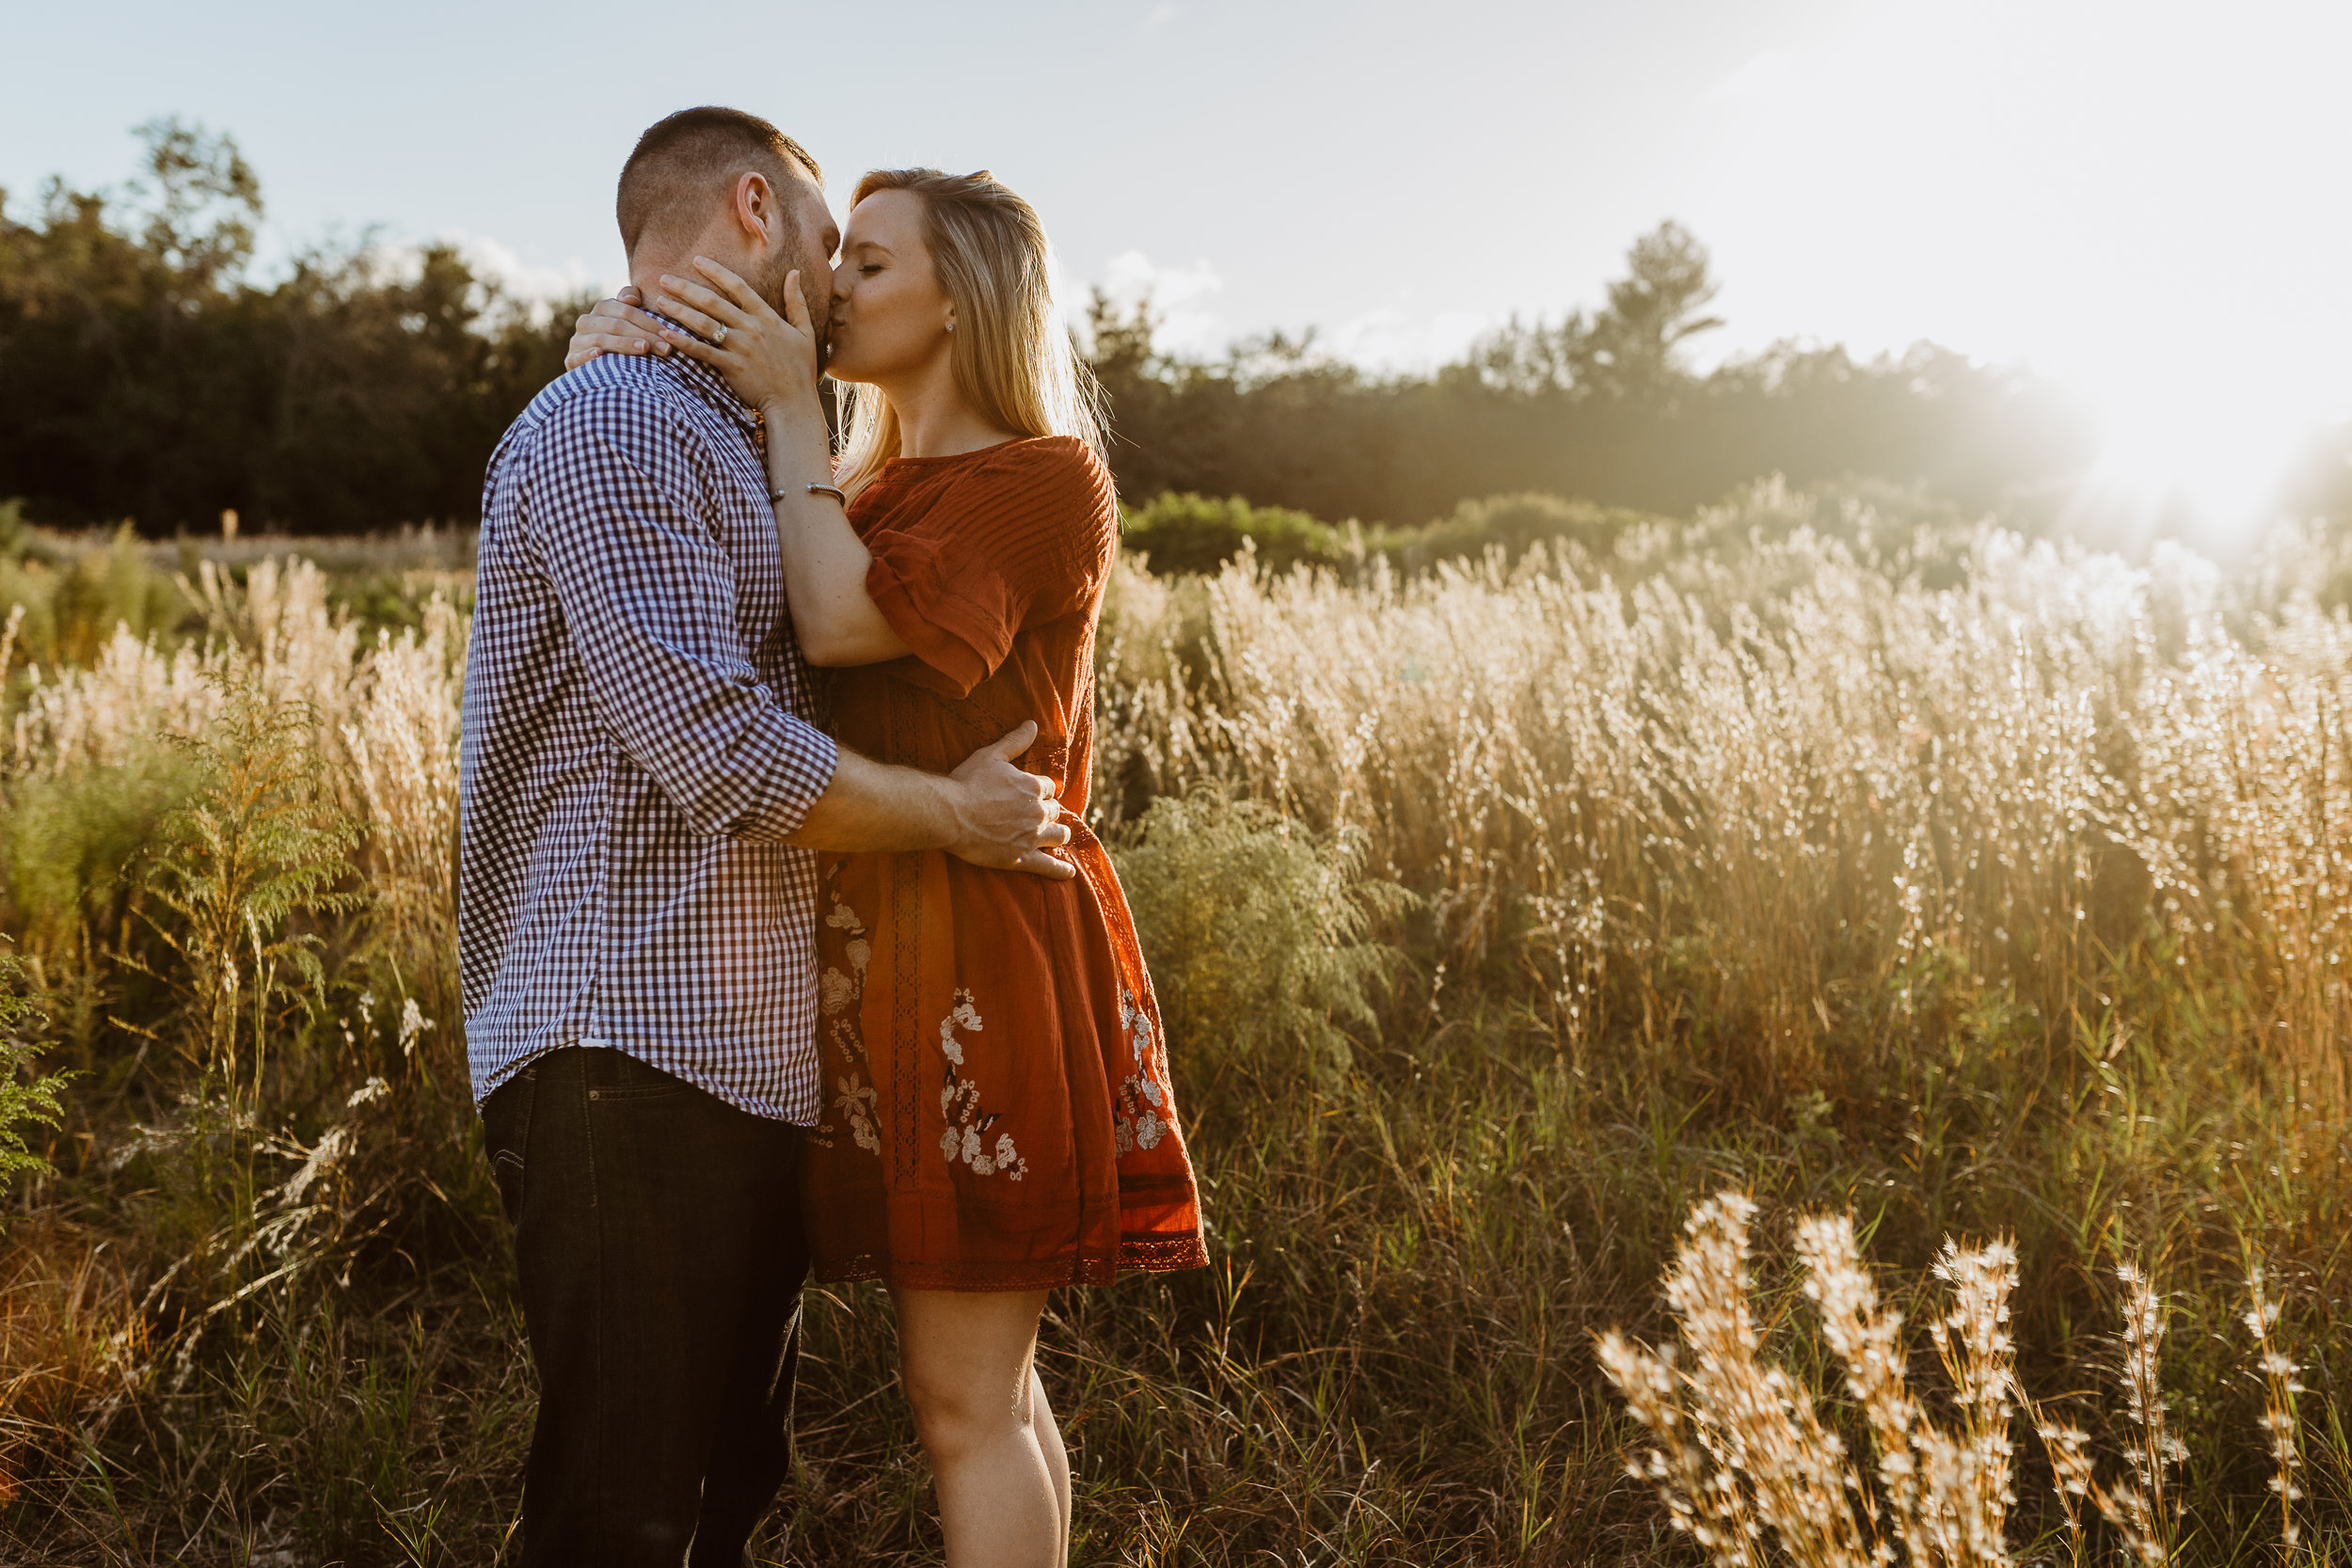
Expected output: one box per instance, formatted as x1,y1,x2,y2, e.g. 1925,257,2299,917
1104,496,2352,1107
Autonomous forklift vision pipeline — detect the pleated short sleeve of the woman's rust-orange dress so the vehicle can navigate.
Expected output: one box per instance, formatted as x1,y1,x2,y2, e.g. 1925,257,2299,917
866,437,1120,696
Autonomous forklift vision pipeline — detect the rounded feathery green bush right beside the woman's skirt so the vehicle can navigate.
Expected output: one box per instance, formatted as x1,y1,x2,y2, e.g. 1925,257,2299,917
1120,787,1406,1084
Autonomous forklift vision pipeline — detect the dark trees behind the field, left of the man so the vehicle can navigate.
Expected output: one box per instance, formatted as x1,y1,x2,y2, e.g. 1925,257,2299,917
0,119,574,533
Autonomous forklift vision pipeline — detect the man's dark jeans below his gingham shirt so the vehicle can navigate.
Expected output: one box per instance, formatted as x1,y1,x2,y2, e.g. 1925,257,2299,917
483,1046,809,1568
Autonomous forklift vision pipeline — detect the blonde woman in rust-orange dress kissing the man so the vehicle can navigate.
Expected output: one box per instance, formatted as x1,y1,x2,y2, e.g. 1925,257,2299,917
574,169,1207,1566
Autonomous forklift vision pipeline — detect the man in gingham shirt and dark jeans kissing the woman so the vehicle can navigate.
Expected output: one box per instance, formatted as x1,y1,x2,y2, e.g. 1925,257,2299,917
459,108,1071,1568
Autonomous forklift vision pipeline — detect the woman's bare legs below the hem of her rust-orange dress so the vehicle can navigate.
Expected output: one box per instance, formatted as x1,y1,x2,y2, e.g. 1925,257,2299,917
892,1291,1068,1568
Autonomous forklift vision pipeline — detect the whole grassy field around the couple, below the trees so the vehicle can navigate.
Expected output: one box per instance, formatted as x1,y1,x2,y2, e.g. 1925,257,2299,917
0,486,2352,1563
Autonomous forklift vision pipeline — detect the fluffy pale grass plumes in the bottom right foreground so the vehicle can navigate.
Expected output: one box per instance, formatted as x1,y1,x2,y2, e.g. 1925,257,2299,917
1599,1192,2300,1568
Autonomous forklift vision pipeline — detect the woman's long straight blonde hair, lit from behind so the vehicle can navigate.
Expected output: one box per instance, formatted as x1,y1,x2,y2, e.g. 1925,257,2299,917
837,169,1104,496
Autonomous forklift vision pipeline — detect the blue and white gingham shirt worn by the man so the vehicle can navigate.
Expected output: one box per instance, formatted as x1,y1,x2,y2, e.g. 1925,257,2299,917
459,355,837,1126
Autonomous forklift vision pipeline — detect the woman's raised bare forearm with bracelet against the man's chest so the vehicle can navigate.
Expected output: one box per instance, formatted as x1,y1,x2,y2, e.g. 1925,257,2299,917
762,400,908,665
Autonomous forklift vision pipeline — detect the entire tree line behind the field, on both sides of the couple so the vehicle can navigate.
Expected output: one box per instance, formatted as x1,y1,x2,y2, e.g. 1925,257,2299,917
13,119,2314,533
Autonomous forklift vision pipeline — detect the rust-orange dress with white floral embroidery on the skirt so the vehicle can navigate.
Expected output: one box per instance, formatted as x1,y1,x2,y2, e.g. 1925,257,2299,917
803,437,1209,1291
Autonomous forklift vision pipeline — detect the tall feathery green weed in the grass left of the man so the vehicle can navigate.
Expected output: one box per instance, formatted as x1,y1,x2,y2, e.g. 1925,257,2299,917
151,682,365,1096
